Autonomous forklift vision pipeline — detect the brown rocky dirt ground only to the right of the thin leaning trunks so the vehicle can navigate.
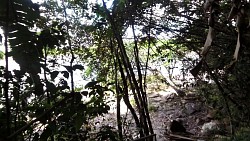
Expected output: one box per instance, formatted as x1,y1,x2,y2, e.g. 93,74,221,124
149,90,206,141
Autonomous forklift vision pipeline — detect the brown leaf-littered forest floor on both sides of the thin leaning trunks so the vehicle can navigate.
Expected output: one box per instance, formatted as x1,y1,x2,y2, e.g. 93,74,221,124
92,83,215,141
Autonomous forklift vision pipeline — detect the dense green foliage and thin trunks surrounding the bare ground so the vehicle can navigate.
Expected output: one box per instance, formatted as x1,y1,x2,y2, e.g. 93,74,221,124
0,0,250,140
